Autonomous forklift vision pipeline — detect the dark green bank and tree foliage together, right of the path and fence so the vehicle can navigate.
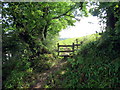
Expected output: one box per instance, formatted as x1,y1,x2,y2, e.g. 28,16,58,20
45,2,120,88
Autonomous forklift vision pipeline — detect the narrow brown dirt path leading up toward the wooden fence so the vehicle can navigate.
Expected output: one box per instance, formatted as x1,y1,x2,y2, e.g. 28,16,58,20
32,60,67,89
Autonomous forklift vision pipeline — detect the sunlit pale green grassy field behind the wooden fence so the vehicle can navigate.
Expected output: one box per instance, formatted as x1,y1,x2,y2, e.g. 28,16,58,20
56,34,100,55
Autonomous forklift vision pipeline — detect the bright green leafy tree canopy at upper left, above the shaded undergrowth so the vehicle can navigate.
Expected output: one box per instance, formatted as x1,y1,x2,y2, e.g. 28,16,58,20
2,2,86,59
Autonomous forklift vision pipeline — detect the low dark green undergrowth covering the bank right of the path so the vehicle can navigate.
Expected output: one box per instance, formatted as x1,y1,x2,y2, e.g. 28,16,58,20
46,35,120,88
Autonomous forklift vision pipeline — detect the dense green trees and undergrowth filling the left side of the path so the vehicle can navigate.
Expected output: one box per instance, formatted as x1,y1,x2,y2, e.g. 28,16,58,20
2,2,85,88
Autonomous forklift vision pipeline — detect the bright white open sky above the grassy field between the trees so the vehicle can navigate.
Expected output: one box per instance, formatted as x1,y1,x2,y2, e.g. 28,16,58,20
59,16,100,38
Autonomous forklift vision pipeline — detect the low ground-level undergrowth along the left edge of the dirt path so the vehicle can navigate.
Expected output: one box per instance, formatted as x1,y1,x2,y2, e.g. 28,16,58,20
2,54,59,89
